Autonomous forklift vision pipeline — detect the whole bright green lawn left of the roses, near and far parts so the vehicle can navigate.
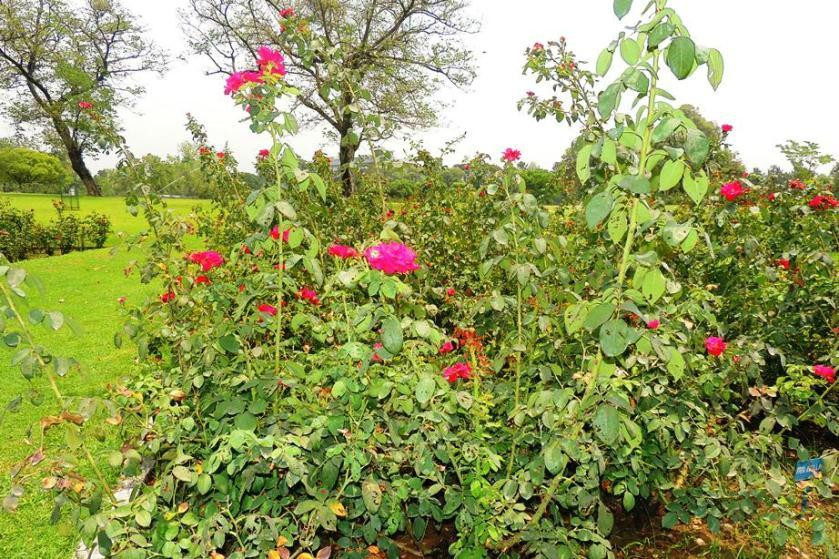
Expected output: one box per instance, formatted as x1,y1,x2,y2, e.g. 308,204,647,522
0,194,206,559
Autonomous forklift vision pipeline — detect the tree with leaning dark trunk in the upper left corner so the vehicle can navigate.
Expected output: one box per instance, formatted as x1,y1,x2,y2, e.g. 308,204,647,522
0,0,165,195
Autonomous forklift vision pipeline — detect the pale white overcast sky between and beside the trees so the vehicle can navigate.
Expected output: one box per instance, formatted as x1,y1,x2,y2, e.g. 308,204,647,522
6,0,839,173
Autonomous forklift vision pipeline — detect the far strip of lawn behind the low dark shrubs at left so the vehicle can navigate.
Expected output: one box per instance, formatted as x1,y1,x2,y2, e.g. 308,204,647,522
0,192,209,246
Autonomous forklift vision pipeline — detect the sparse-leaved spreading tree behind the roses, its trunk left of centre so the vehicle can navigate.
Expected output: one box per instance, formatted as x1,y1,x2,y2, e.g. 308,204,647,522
181,0,477,195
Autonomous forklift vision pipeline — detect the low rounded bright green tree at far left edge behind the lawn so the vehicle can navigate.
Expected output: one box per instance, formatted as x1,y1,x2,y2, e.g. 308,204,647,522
0,147,71,192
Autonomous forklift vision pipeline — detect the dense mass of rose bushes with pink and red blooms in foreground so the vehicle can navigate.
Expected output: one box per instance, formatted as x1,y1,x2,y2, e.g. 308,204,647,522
3,0,837,559
